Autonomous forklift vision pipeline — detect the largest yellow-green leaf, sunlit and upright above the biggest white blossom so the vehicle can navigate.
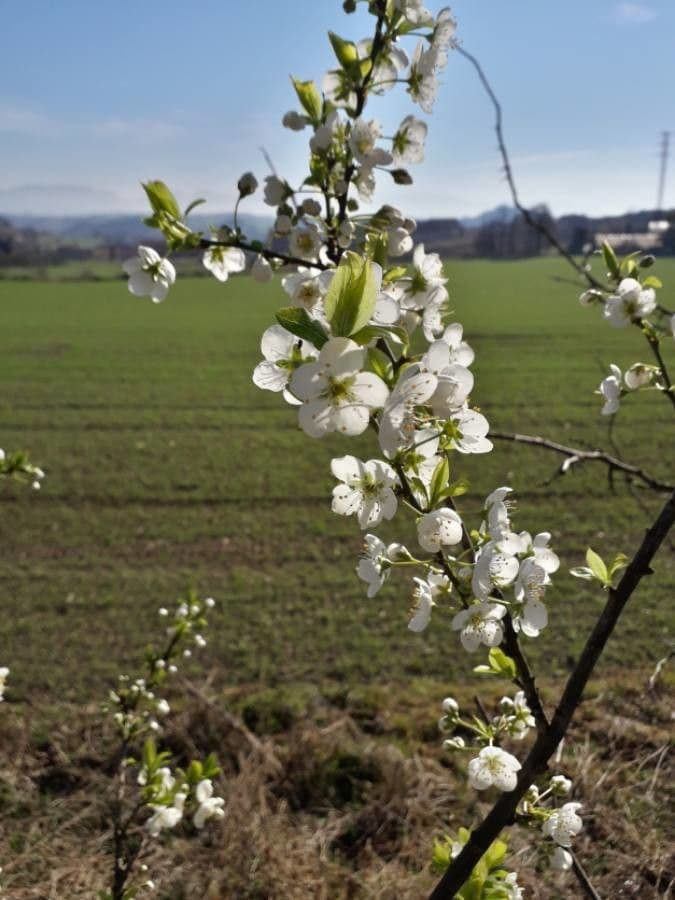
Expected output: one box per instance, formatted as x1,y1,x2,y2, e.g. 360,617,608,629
324,252,377,337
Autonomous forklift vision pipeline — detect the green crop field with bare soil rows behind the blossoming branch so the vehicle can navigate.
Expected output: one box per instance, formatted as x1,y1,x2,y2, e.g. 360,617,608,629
0,253,675,703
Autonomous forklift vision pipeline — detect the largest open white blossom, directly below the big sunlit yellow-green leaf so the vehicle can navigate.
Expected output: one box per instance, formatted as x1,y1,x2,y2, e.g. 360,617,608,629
290,337,389,437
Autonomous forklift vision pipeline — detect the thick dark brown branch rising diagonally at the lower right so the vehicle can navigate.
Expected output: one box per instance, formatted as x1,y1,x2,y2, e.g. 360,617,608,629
429,491,675,900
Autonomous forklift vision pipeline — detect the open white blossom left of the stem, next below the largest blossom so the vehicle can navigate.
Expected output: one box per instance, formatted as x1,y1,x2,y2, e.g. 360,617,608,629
331,456,399,528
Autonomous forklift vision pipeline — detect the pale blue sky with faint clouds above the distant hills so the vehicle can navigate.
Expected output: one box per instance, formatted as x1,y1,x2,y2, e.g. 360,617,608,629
0,0,675,217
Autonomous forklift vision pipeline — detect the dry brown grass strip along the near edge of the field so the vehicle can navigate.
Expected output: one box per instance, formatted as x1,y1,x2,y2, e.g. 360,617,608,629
0,676,675,900
